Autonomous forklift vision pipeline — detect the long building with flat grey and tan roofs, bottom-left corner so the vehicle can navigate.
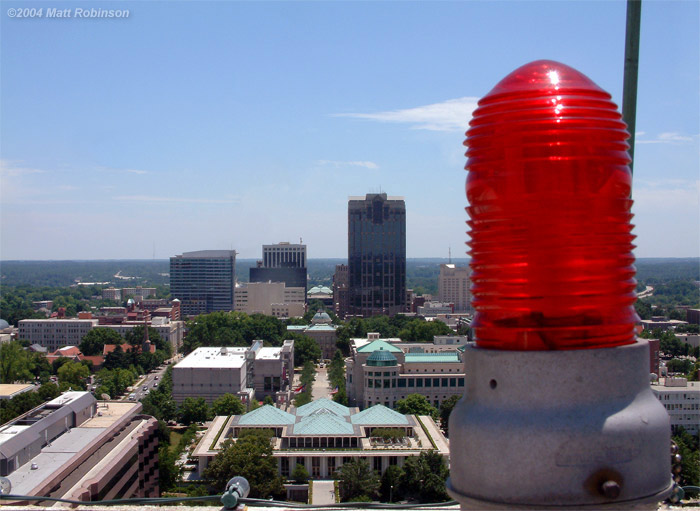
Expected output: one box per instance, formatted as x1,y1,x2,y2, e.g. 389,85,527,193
0,392,158,501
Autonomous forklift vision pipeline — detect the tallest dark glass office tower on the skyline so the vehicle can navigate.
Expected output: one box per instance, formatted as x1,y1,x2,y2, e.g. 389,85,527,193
348,193,406,317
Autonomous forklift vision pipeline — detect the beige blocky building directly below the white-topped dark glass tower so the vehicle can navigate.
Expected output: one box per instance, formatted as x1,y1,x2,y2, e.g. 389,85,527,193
235,282,306,318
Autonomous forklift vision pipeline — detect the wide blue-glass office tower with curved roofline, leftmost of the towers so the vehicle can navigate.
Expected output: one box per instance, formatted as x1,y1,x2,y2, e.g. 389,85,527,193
170,250,236,316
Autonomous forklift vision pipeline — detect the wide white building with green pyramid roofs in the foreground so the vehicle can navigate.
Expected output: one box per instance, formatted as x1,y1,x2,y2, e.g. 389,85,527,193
193,398,449,479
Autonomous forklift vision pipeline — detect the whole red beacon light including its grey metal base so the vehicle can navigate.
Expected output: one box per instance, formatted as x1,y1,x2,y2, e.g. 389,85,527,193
447,60,673,511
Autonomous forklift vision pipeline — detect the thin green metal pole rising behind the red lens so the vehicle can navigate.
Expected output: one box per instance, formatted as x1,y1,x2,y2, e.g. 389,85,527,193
622,0,642,177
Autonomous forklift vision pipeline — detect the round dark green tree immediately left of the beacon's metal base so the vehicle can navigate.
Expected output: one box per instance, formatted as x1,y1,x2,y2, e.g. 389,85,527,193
401,451,450,502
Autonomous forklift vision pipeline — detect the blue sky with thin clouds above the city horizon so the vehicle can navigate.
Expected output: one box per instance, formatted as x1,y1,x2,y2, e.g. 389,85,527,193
0,0,700,260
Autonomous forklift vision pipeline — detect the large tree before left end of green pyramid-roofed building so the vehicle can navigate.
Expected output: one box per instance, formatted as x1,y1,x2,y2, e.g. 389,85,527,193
204,430,284,498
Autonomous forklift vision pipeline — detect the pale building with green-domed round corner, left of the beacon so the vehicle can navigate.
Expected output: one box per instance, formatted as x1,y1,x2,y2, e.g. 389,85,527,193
345,334,464,408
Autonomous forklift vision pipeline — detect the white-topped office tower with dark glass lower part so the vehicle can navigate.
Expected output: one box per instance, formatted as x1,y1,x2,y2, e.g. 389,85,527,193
250,242,306,289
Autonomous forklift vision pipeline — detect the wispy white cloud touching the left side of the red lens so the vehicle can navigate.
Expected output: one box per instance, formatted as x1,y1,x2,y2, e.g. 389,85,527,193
334,96,479,131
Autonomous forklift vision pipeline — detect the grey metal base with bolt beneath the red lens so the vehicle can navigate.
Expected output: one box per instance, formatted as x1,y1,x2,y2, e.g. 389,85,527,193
447,340,673,510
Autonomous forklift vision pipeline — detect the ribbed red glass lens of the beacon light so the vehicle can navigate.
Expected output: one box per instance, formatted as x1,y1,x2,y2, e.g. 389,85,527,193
464,60,637,350
